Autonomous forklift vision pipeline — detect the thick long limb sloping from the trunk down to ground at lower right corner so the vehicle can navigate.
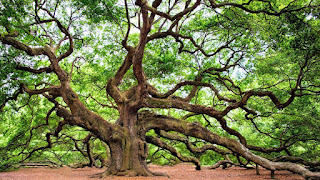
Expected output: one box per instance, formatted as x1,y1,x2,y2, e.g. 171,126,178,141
141,112,320,178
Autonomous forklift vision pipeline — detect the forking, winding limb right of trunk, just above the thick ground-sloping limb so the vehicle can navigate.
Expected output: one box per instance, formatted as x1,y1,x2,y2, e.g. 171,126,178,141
147,72,312,148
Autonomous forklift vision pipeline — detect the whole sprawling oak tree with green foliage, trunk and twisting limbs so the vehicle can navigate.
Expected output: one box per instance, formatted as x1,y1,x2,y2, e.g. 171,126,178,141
0,0,320,179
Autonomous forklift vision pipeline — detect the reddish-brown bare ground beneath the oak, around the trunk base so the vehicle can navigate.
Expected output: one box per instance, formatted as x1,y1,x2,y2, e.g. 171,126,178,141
0,164,304,180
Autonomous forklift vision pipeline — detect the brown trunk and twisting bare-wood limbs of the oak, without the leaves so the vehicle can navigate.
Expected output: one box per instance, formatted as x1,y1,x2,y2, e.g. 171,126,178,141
0,0,320,179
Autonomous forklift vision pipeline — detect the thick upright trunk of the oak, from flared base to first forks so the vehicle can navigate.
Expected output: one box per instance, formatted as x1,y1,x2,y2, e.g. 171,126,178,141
90,107,155,177
